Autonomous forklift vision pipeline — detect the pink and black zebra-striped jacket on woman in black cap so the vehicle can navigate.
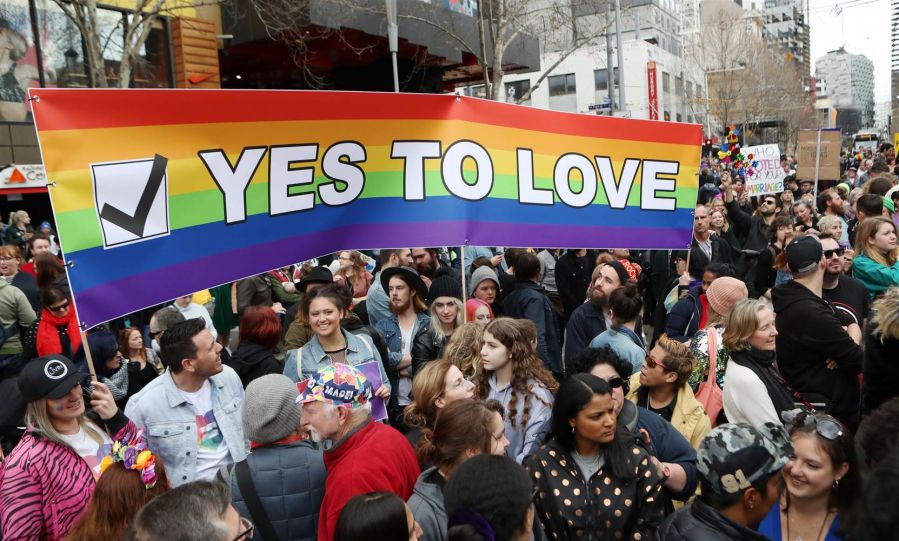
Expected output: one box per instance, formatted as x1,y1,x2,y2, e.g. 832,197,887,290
0,410,138,541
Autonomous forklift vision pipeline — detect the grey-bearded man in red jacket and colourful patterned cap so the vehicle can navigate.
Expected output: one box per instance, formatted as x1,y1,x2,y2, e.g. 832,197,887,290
297,364,420,541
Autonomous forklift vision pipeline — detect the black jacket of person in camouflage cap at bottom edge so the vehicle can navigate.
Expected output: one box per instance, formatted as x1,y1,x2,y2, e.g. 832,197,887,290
656,500,769,541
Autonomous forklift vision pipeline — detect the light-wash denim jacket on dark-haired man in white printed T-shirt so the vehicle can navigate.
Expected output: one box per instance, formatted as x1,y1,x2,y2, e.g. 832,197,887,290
125,365,247,487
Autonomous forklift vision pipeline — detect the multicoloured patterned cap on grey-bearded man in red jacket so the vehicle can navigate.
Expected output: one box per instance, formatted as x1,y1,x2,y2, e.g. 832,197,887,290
297,363,372,409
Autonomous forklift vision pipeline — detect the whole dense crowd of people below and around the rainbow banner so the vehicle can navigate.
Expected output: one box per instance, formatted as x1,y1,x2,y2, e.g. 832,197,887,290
0,143,899,541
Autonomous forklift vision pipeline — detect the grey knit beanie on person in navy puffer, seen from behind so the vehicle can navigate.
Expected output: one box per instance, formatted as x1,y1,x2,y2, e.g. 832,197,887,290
243,374,300,443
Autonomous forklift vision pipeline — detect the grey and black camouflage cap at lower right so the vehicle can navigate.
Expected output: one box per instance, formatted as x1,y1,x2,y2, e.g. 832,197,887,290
696,423,793,496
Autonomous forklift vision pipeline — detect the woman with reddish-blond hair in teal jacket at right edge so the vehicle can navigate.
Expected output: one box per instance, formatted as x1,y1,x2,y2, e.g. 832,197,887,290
852,216,899,297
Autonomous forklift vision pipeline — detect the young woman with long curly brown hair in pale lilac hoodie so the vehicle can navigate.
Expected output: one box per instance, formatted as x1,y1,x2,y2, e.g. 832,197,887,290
475,317,558,463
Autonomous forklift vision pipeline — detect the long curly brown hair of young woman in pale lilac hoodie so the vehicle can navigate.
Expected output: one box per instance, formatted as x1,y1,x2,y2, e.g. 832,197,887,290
475,317,559,429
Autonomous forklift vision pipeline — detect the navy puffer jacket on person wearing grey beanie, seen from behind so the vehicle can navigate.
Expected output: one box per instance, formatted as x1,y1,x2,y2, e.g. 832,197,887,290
231,441,327,540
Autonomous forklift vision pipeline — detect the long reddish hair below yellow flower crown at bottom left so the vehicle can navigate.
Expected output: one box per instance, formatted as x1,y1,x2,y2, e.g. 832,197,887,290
66,455,171,541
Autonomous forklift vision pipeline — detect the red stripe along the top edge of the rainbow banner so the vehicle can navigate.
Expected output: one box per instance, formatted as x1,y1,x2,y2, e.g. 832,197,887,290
30,88,702,145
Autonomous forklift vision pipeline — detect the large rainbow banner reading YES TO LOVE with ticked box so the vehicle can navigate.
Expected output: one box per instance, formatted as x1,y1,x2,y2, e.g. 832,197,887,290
31,89,702,327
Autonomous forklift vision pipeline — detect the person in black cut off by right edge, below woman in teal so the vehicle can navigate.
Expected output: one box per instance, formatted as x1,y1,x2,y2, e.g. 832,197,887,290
862,286,899,412
